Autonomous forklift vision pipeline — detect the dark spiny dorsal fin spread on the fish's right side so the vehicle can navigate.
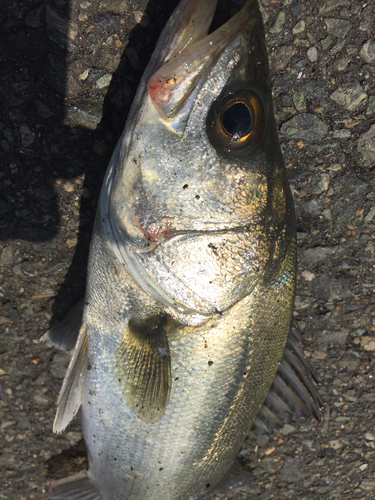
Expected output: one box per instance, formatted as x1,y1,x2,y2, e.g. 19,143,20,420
252,327,323,435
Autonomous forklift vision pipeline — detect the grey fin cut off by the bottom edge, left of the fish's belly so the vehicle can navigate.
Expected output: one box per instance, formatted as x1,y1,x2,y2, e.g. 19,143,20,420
47,471,103,500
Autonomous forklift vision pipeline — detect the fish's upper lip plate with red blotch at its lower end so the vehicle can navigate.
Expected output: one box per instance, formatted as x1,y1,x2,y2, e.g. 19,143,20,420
147,0,259,123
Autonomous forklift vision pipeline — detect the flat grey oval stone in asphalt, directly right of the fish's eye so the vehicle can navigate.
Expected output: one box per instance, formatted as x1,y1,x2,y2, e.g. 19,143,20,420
280,113,328,142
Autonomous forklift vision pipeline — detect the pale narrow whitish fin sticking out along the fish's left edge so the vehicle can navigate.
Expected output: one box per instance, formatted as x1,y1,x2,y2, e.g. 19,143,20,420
53,326,87,433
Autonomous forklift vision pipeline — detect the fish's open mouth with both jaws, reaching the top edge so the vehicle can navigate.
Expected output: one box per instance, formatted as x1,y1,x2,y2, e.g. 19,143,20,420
147,0,259,122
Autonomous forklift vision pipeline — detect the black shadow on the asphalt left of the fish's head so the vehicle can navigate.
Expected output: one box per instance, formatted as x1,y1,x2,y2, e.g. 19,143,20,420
0,0,178,326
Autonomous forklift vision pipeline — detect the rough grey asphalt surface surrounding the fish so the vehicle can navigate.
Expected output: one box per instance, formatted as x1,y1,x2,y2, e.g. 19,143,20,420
0,0,375,500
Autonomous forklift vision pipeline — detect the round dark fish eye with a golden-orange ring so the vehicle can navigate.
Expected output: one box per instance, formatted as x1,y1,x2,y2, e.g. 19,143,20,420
206,89,265,153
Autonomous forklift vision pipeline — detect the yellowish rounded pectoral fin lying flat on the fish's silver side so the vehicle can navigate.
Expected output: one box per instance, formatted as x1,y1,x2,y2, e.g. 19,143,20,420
115,315,172,423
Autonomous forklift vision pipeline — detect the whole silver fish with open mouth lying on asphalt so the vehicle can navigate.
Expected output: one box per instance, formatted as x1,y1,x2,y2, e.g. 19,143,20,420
44,0,322,500
